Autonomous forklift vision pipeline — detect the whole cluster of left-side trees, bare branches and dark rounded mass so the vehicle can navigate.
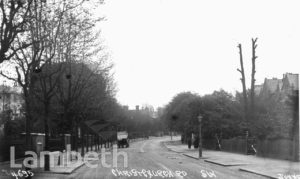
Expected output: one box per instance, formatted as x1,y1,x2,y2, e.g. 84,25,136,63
0,0,118,170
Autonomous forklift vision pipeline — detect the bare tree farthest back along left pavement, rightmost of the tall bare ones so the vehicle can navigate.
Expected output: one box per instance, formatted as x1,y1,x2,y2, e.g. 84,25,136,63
52,1,105,153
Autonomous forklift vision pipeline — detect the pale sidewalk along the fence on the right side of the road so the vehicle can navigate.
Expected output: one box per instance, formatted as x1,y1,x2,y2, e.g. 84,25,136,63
164,141,300,178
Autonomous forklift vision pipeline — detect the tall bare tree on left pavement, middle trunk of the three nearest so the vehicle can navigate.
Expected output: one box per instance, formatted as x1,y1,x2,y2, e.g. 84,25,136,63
30,1,97,171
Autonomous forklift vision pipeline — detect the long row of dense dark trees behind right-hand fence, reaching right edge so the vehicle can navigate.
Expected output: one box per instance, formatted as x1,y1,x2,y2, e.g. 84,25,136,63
162,90,299,142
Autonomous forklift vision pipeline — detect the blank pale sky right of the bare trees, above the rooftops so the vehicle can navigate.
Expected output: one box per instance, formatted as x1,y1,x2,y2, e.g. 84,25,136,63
98,0,300,108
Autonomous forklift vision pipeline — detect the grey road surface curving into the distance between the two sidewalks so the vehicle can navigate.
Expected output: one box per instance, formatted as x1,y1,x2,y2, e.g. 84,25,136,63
34,137,264,179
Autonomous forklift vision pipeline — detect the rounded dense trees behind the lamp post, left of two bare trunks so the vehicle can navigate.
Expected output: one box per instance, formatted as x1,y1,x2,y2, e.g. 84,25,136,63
163,90,242,141
